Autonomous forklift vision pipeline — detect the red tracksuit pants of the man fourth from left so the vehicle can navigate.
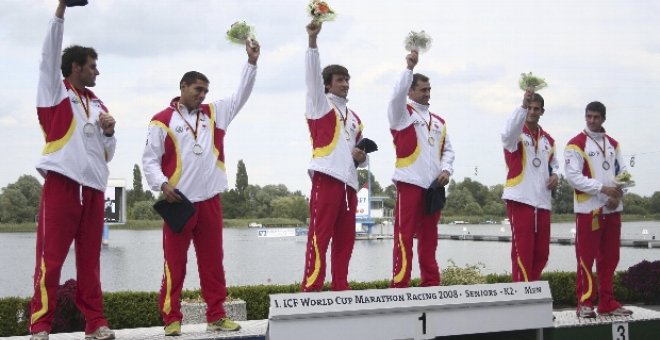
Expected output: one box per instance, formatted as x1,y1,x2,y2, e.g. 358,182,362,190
390,182,440,288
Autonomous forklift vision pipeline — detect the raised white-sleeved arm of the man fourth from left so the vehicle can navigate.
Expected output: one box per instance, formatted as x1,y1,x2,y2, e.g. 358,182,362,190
387,51,419,130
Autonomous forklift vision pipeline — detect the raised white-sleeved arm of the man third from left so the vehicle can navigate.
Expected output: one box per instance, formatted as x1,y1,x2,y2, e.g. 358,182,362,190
305,22,330,119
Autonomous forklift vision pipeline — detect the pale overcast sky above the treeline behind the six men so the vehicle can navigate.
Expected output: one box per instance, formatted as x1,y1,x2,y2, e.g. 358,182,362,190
0,0,660,196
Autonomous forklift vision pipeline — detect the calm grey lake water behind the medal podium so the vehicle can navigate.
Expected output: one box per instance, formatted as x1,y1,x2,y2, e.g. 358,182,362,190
0,221,660,297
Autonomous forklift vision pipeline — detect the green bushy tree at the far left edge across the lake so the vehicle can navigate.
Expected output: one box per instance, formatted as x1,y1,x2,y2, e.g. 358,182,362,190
0,175,41,223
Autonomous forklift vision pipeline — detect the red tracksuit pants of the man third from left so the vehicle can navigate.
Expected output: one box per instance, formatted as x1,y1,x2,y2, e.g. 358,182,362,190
302,171,357,292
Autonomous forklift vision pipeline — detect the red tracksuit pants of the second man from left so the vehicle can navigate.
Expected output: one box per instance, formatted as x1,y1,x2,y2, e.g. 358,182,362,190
159,195,227,325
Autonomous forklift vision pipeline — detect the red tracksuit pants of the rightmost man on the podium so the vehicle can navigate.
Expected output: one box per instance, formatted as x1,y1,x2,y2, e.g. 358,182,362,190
575,213,621,313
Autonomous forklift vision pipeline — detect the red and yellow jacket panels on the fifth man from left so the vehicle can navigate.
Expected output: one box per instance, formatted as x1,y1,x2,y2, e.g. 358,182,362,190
504,125,555,188
